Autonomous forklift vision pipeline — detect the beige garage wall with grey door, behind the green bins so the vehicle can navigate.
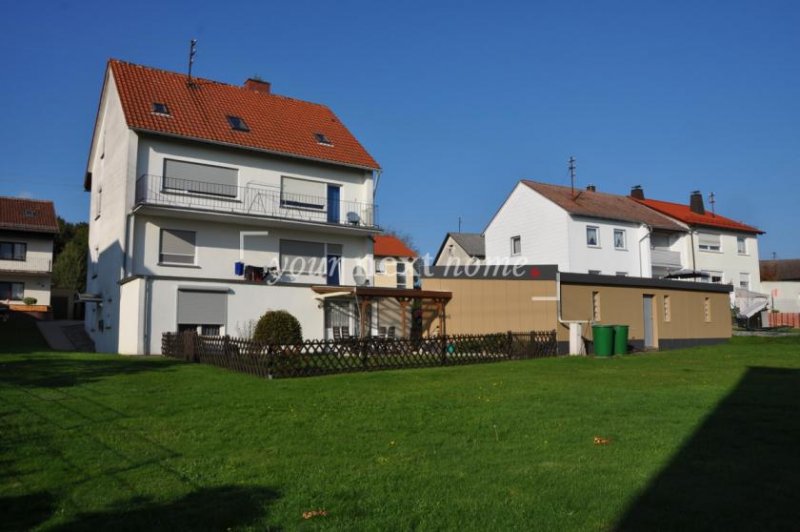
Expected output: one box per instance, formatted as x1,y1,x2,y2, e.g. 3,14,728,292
559,283,731,340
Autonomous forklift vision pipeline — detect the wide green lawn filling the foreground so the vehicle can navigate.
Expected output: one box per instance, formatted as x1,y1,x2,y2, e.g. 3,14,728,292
0,322,800,530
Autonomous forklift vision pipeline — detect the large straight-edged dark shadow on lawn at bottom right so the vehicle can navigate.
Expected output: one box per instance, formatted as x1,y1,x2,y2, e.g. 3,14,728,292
615,367,800,531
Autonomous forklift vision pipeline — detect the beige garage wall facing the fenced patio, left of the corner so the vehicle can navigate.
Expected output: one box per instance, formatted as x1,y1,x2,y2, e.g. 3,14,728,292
422,278,558,334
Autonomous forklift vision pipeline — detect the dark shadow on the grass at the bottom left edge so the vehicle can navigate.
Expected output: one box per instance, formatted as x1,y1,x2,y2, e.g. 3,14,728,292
49,486,280,532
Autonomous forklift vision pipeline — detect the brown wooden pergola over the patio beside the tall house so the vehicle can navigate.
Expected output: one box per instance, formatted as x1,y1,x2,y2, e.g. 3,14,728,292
311,286,453,338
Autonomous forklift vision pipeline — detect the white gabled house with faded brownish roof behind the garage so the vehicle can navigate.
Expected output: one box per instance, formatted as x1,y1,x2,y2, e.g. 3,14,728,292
483,180,688,277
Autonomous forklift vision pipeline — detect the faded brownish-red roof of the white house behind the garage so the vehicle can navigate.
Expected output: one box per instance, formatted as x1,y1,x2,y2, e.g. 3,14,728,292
522,179,686,232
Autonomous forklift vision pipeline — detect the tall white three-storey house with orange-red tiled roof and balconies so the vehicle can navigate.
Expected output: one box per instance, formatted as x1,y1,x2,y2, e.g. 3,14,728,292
83,60,380,353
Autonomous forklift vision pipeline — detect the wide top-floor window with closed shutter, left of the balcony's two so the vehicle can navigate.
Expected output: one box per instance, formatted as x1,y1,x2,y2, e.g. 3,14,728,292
163,159,239,198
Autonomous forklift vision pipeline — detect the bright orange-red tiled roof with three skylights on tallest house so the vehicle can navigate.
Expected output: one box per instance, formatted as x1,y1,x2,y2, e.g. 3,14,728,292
108,59,380,169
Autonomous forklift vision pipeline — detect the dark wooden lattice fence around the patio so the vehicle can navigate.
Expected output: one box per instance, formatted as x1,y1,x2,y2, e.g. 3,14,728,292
161,331,558,378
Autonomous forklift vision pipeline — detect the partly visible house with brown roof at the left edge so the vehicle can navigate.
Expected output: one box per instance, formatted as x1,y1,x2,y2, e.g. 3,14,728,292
0,197,58,306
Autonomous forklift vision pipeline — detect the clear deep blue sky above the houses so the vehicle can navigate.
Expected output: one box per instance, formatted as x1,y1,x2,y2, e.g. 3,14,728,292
0,0,800,258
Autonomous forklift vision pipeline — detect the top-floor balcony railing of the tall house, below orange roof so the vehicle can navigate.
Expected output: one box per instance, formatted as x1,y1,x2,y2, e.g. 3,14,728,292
136,175,377,227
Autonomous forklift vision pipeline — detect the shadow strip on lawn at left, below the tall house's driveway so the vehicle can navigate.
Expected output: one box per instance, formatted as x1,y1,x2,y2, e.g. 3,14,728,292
0,354,181,388
